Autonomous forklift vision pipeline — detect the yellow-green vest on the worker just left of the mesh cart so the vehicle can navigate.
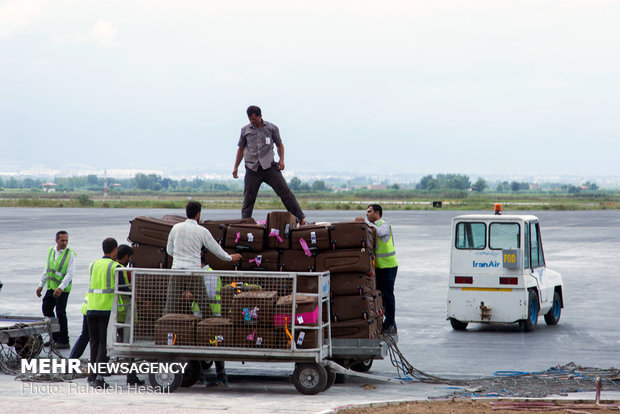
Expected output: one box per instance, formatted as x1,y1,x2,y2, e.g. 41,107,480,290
86,257,120,311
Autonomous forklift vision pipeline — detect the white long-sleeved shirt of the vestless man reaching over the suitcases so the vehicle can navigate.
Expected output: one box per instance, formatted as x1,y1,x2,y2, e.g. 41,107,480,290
166,219,232,269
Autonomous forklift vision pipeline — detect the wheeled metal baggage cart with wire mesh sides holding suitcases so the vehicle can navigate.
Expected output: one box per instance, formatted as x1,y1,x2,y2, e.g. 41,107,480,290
107,268,336,395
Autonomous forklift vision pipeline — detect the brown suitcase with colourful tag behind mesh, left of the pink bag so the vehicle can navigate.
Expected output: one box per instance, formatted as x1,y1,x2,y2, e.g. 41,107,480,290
231,290,278,329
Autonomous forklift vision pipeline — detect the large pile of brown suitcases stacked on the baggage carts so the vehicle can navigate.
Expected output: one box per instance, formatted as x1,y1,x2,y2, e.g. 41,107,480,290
129,211,384,347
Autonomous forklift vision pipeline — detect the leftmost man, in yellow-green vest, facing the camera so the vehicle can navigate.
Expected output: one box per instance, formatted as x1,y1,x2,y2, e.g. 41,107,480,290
36,230,76,349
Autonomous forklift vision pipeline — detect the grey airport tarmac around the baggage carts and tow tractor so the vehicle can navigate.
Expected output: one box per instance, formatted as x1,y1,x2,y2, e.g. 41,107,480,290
0,208,620,414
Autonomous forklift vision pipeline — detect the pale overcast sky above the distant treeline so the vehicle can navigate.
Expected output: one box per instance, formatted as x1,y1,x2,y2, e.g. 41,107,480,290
0,0,620,175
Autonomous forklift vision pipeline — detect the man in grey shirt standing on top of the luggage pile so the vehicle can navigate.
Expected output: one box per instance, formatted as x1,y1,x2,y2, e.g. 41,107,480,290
233,106,306,224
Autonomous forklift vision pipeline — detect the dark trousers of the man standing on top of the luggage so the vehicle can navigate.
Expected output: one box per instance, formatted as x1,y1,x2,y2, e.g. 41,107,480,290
241,164,306,221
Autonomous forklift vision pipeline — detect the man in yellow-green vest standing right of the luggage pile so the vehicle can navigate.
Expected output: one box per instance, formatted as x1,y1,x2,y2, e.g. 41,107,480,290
355,204,398,335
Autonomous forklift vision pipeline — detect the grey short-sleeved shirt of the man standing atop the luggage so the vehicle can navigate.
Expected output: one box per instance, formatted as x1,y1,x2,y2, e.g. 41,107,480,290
237,120,282,171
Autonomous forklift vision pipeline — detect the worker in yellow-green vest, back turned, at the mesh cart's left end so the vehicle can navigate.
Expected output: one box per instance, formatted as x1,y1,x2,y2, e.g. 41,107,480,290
86,237,121,388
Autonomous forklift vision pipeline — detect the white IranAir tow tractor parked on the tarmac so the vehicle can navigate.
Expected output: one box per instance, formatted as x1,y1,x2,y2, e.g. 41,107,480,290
447,205,564,332
